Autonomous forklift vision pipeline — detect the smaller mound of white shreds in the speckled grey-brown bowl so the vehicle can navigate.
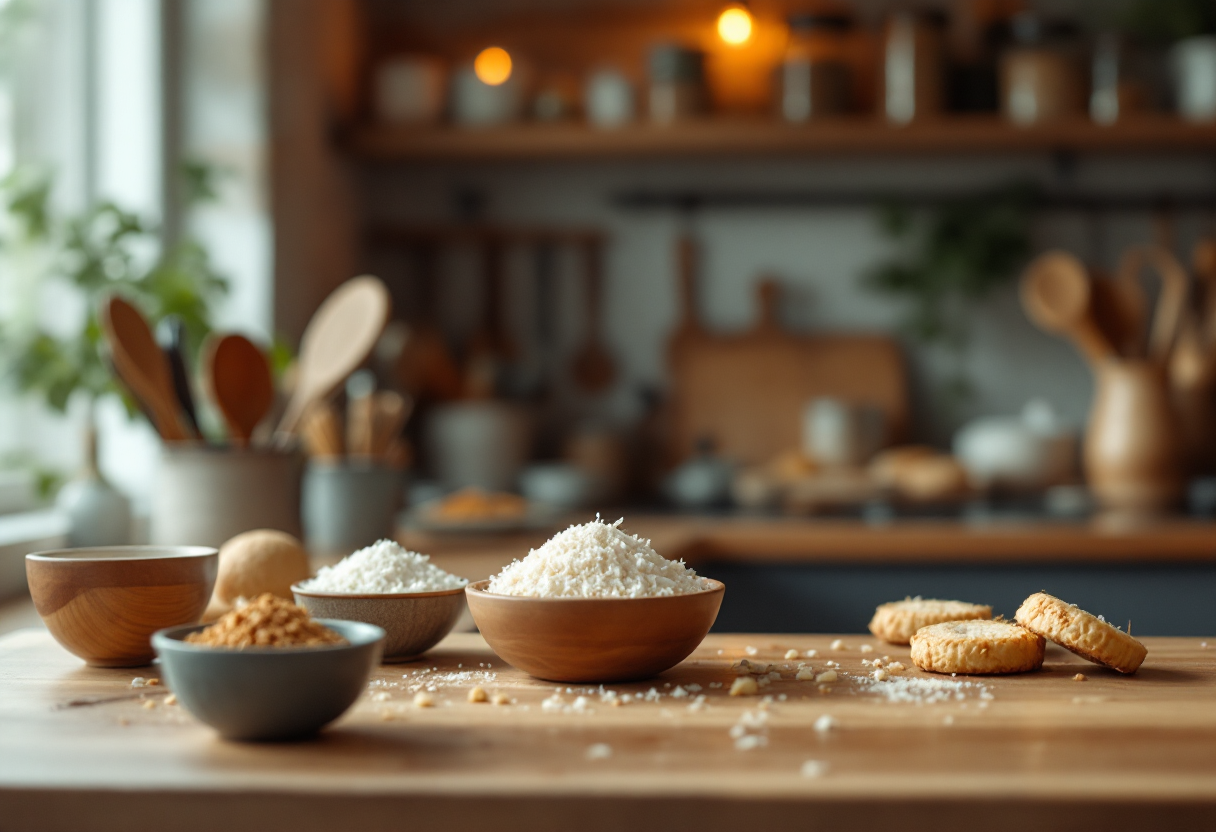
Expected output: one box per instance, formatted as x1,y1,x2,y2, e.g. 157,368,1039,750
300,540,468,595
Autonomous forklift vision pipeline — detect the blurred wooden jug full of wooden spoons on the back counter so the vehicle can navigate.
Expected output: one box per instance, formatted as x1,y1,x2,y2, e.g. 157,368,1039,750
1021,242,1216,511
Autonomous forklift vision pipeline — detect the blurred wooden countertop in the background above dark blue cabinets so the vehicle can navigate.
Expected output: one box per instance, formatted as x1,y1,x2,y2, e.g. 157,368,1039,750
398,515,1216,578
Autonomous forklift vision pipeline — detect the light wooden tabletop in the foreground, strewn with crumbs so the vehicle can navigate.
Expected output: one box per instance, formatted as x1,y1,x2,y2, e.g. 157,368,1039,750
0,630,1216,832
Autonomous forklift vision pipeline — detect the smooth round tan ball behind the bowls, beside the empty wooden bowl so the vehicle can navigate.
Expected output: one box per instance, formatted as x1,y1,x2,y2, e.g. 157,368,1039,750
203,529,310,620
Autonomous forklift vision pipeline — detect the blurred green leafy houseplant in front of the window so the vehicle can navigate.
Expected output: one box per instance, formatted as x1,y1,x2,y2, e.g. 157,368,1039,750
0,165,227,545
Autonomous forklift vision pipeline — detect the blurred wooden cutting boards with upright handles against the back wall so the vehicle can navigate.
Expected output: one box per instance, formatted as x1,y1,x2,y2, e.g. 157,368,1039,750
669,246,908,465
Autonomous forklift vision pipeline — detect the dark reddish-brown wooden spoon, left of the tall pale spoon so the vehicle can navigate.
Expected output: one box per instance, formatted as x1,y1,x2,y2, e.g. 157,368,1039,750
203,335,275,448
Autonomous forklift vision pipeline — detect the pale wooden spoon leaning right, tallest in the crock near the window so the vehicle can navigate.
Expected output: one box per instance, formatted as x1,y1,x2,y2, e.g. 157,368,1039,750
276,275,389,444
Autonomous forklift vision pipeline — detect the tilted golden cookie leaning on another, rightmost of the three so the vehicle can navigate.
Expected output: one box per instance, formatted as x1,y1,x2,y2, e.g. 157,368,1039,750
1014,592,1148,673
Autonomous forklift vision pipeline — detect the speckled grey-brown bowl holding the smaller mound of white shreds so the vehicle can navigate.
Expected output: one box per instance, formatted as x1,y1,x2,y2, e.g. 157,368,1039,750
292,584,465,662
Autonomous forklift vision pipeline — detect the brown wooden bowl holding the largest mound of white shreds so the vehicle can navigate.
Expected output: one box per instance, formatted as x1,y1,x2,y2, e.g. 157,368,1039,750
465,580,726,682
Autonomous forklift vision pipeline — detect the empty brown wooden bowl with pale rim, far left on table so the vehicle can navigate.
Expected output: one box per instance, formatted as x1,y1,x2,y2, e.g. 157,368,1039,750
26,546,219,668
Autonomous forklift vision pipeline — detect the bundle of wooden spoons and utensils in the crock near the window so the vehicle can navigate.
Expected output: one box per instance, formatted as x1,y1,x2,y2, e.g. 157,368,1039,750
101,276,393,448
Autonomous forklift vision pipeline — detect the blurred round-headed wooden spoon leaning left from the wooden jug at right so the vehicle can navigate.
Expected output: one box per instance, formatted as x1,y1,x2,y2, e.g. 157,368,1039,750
1020,251,1115,365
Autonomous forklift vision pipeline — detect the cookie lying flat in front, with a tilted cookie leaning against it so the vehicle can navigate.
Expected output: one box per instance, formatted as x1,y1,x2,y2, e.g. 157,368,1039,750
912,620,1047,674
